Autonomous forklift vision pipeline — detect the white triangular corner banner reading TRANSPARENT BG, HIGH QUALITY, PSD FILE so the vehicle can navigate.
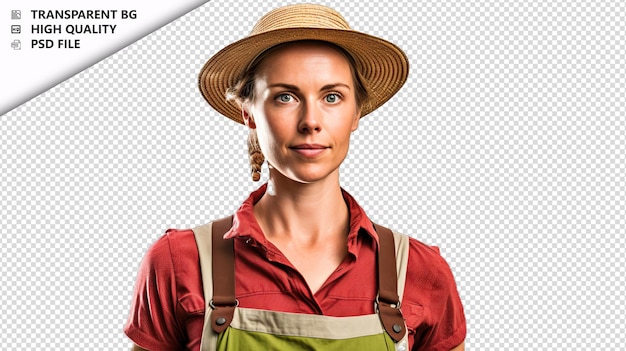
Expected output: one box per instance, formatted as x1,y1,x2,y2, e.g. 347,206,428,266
0,0,207,115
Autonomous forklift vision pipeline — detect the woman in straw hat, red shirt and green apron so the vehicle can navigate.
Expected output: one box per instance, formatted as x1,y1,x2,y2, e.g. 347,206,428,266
125,5,465,351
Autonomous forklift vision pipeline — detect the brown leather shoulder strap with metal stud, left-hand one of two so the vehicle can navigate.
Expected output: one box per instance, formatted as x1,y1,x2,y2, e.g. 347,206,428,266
209,216,238,334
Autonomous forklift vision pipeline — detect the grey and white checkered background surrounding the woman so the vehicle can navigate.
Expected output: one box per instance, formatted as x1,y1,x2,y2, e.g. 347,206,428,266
0,1,626,350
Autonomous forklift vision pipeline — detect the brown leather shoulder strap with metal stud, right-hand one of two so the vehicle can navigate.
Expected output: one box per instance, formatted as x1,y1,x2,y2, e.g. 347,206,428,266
374,224,406,342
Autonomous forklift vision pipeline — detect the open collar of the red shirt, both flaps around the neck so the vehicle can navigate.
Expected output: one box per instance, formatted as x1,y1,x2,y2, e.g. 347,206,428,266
224,184,378,246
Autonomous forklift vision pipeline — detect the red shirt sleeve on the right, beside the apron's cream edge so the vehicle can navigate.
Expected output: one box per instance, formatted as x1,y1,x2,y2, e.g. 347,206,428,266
402,239,466,351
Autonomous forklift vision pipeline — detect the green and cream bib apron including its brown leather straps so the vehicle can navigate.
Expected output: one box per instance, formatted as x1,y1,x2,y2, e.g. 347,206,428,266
193,217,409,351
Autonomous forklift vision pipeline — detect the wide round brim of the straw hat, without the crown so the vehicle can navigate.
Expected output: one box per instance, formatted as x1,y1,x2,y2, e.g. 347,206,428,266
199,28,409,124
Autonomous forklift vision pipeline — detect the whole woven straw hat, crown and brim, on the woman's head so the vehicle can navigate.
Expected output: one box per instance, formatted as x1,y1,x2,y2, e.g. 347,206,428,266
199,4,409,124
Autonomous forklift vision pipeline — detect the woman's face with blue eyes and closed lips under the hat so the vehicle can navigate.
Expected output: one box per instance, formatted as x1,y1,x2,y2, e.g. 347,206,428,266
244,42,360,183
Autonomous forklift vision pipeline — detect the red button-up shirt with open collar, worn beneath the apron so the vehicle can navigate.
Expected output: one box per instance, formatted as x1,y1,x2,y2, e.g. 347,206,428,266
124,186,465,351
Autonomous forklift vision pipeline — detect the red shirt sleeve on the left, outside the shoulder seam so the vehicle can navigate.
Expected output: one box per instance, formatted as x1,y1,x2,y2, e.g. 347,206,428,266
124,234,184,351
